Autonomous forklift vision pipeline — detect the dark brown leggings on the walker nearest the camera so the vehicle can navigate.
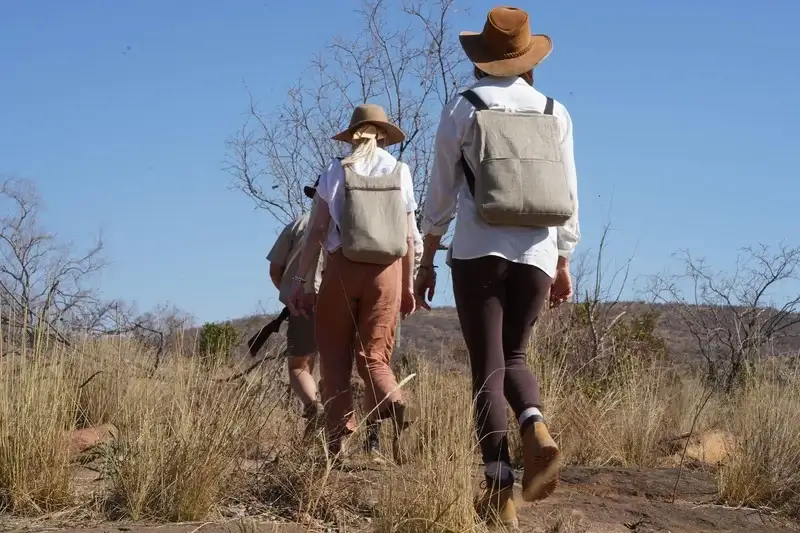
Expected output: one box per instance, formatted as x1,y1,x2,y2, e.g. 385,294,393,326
451,256,552,463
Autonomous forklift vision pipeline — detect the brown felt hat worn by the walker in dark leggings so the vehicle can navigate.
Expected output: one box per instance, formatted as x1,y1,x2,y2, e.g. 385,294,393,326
458,7,553,76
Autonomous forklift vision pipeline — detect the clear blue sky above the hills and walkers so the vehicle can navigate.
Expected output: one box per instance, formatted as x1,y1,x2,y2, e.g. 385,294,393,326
0,0,800,320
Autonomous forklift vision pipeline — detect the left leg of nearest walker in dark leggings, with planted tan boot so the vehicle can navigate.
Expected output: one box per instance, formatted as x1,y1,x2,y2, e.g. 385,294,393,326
451,256,517,526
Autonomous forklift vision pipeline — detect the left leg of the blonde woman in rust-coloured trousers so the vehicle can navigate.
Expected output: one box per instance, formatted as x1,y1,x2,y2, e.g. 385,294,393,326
315,253,359,453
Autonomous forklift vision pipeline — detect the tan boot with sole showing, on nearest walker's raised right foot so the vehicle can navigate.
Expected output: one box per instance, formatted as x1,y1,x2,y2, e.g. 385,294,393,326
522,421,561,502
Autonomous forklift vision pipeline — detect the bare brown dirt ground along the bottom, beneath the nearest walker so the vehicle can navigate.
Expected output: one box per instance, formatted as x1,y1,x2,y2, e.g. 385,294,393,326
9,467,800,533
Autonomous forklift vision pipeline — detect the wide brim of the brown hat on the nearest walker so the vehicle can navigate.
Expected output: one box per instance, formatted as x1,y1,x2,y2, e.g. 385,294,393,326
458,31,553,76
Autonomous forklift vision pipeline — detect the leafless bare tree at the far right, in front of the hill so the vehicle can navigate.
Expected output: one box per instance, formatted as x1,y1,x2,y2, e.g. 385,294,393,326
652,243,800,391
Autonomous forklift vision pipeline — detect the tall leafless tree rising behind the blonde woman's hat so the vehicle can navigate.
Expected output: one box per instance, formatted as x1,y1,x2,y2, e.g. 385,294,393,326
228,0,469,230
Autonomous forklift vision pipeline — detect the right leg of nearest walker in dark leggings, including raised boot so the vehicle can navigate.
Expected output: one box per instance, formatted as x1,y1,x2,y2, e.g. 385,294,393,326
503,264,560,501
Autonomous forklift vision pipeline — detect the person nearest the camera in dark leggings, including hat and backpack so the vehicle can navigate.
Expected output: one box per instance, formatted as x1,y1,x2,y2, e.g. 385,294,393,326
415,7,580,527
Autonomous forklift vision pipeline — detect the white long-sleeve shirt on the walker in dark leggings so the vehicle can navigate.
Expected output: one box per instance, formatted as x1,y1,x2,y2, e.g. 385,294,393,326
421,76,580,277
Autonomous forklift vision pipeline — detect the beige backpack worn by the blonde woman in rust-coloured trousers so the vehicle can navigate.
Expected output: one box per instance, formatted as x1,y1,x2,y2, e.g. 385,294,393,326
339,161,408,265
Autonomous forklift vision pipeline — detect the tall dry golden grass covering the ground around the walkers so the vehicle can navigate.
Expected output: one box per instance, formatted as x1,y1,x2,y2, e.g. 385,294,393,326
0,306,800,533
